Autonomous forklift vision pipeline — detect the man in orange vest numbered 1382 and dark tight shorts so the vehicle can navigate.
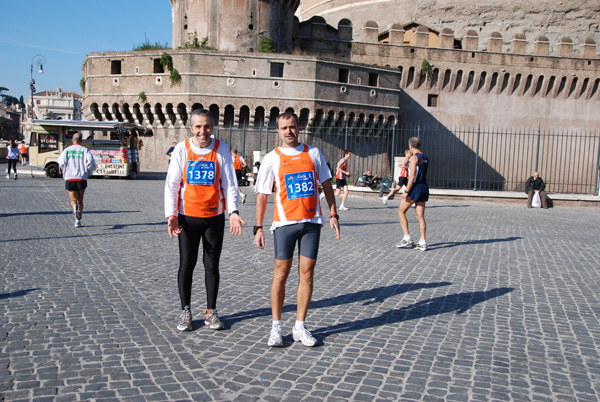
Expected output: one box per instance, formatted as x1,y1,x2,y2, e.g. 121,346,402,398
254,112,340,346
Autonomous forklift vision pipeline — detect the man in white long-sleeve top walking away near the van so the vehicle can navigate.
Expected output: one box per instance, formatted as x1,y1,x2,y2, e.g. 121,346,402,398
58,133,96,228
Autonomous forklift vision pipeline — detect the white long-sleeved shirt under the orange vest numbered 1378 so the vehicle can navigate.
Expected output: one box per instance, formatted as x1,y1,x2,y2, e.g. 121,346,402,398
165,138,239,218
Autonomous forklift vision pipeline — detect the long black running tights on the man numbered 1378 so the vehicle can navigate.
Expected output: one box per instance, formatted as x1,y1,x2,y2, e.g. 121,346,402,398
177,214,225,310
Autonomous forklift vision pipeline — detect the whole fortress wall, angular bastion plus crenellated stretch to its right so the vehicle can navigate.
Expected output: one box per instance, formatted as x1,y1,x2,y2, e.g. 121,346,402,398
83,0,600,176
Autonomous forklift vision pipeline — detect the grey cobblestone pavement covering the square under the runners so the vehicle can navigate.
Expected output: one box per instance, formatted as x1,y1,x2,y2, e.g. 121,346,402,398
0,174,600,401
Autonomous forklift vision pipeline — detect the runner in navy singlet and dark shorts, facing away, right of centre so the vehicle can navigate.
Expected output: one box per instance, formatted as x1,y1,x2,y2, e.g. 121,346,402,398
396,137,429,251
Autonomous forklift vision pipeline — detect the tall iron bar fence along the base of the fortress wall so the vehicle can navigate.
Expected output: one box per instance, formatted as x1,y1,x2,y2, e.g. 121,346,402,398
215,124,600,195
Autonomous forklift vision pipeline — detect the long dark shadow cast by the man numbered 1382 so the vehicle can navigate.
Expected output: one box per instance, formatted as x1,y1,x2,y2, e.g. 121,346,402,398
312,288,514,341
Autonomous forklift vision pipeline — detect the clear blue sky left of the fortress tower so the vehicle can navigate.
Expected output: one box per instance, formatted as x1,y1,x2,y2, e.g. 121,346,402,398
0,0,171,101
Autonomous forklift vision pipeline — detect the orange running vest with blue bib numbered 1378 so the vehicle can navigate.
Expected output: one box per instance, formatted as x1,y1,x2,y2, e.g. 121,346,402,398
179,138,225,218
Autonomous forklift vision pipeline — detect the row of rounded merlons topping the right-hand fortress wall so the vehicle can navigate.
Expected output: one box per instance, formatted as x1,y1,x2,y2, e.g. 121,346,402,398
294,16,599,58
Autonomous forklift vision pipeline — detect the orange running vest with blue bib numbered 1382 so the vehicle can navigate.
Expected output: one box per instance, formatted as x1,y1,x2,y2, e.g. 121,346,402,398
273,144,322,222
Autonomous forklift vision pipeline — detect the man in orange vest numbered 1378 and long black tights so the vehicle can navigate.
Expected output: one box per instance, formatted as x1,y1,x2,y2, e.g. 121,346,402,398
165,109,246,331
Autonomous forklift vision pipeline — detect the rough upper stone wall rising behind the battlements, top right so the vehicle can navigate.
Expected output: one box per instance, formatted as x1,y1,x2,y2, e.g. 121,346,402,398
296,0,600,52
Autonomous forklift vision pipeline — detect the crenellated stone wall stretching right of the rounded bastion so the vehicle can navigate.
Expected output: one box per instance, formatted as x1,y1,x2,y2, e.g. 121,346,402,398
295,17,600,130
